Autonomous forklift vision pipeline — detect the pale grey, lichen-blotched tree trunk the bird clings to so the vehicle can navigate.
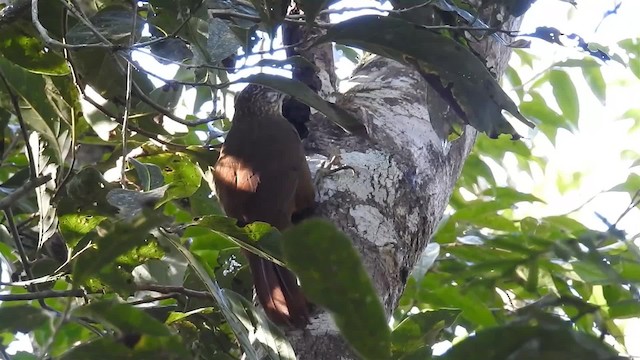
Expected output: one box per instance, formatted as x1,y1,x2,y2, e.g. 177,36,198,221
289,4,520,360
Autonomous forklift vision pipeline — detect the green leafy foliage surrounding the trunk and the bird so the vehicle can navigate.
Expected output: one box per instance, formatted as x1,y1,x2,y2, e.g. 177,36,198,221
0,0,640,359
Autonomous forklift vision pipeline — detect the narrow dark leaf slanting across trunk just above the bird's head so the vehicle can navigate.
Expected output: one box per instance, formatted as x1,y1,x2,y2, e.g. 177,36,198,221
238,74,366,134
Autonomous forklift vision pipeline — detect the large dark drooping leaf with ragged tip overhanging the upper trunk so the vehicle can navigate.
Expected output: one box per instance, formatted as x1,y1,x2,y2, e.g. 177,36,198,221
316,15,533,137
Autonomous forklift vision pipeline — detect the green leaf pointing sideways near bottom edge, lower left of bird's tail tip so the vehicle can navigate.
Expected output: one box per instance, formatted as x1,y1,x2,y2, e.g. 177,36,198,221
73,300,171,336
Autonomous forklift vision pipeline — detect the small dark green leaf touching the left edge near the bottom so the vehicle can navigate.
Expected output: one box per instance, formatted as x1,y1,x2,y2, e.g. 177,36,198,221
0,304,51,333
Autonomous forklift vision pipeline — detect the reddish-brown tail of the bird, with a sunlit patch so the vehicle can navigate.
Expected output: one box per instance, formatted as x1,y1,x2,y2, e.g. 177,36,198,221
247,253,309,328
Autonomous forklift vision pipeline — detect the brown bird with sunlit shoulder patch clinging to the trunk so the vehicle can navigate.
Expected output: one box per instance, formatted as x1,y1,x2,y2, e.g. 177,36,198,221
214,84,315,327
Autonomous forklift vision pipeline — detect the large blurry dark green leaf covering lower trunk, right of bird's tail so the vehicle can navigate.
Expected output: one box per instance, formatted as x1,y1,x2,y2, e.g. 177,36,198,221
283,220,390,359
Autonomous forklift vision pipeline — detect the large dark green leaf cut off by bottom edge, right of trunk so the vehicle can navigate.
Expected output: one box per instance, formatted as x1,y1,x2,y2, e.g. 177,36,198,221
439,325,617,360
